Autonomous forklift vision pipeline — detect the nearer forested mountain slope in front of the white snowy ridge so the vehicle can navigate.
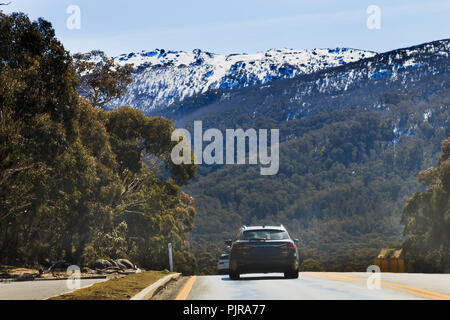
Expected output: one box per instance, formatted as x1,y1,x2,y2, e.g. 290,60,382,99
172,40,450,270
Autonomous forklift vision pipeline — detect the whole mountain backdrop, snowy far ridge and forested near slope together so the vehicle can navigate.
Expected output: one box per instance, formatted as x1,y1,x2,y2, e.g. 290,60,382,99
104,39,450,272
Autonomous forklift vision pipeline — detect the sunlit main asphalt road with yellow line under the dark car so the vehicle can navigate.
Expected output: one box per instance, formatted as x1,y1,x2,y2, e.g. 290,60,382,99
187,272,450,300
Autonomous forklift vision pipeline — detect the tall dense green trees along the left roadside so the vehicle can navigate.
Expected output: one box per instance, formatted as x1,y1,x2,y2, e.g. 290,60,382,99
0,12,196,273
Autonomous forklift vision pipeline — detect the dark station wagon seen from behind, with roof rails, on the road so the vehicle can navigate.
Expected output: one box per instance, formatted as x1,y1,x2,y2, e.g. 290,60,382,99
226,226,299,280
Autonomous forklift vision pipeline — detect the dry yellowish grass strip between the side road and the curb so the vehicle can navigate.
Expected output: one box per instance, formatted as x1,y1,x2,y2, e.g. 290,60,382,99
51,271,169,300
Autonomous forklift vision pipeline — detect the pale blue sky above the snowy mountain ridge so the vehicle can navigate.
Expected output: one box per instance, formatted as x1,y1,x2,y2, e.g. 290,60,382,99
2,0,450,56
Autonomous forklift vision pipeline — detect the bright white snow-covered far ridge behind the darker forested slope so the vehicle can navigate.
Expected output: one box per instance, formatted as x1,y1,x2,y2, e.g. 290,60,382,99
110,48,376,113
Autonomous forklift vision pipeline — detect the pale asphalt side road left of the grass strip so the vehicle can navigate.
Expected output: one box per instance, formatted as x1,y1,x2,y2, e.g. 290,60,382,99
0,279,105,300
